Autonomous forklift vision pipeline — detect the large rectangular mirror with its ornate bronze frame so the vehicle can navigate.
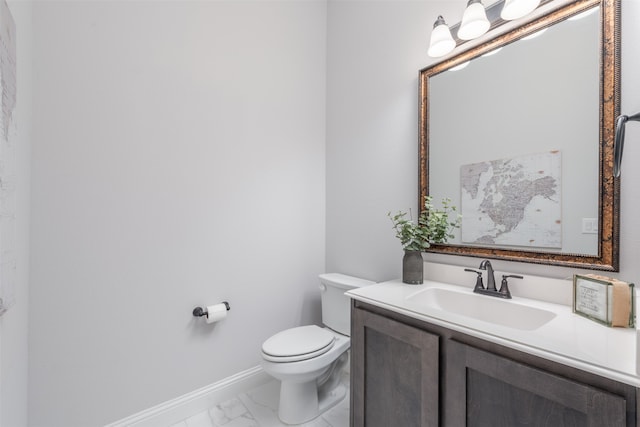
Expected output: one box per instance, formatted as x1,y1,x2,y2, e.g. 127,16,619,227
420,0,620,271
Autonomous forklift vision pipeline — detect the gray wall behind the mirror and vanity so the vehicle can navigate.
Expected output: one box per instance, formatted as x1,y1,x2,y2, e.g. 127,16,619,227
327,0,640,282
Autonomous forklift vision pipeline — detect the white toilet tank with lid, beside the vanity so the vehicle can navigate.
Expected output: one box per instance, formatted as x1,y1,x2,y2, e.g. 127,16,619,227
319,273,375,336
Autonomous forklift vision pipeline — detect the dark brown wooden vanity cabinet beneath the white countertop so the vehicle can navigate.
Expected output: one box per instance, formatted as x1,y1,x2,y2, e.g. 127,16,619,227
351,301,638,427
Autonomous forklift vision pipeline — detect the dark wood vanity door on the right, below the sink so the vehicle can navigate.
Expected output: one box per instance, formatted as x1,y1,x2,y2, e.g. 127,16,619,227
445,341,634,427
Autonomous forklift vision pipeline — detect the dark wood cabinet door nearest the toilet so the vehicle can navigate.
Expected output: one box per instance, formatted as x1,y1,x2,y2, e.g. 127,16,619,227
351,309,439,427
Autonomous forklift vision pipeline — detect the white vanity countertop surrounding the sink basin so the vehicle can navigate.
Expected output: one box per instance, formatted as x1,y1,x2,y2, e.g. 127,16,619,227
346,280,640,387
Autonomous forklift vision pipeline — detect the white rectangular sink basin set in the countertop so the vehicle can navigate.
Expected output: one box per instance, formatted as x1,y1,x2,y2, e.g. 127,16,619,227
407,288,556,331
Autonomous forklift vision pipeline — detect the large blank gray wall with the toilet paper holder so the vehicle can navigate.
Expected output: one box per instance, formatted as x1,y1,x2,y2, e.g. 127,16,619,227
29,1,326,427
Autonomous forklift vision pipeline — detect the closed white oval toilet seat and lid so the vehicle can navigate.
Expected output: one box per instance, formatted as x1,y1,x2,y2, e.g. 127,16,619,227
262,325,335,362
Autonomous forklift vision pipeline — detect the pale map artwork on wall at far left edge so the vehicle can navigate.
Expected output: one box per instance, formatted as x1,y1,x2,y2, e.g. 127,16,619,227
0,0,17,315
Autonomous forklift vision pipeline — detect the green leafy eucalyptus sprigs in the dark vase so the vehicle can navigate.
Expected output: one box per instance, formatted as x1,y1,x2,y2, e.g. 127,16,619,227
387,196,462,251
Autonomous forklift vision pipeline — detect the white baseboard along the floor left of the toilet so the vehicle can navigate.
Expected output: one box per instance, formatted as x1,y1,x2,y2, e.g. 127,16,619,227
105,366,273,427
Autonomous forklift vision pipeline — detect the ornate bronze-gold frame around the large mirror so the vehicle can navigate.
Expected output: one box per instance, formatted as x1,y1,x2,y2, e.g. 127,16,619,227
419,0,620,271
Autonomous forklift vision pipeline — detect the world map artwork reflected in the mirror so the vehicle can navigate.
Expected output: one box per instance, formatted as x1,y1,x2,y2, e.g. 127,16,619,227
460,151,562,248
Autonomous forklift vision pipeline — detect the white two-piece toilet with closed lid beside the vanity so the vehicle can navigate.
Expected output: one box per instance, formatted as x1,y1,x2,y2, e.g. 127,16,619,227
262,273,374,424
